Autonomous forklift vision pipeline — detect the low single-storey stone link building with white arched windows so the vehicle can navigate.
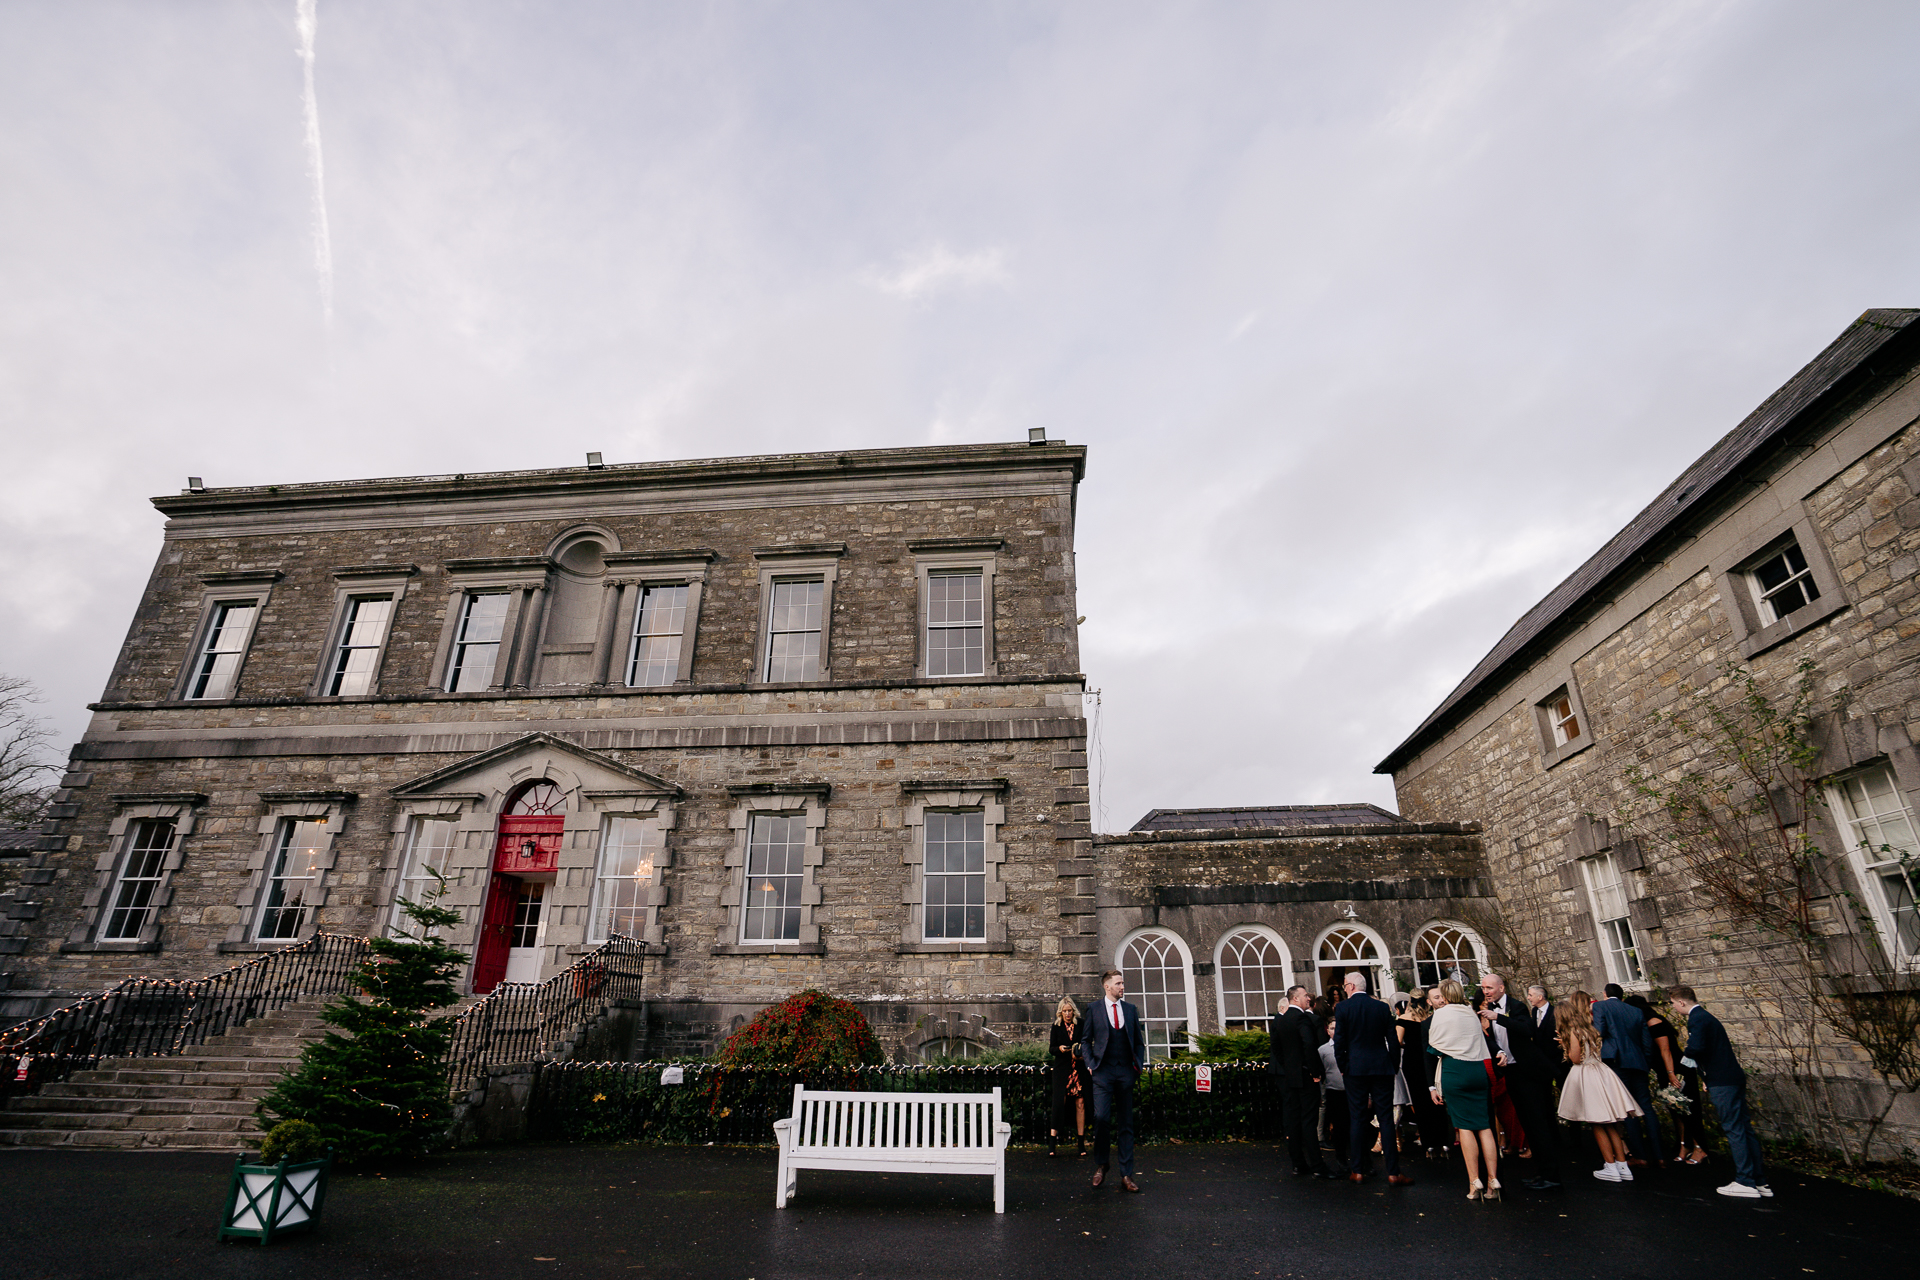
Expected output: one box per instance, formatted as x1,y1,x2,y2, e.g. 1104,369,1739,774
1094,804,1494,1048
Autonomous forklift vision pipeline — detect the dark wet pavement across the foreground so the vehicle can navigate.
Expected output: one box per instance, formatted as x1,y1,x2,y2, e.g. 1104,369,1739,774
0,1144,1920,1280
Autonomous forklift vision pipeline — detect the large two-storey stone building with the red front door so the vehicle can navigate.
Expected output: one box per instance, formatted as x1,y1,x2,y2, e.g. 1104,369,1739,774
0,441,1098,1048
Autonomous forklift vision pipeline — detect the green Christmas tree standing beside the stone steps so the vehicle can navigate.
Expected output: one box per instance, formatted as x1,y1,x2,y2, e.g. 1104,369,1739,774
255,871,467,1163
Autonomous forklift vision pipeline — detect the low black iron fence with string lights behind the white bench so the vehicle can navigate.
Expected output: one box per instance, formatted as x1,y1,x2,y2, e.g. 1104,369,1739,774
528,1061,1281,1146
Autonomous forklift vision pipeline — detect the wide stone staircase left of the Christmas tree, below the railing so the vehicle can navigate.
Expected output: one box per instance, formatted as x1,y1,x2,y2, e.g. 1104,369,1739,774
0,1000,326,1151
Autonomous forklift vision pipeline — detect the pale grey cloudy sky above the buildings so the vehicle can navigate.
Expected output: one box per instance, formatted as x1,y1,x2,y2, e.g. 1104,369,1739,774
0,0,1920,829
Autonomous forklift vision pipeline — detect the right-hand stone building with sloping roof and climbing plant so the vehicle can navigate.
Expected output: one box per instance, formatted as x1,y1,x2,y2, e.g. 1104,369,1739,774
1379,311,1920,1150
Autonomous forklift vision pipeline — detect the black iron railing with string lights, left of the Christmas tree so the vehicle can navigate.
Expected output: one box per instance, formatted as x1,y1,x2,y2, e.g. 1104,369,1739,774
0,933,369,1098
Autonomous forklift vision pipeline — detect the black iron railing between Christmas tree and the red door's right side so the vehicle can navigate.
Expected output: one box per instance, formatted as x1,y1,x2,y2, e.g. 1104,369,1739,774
445,936,647,1096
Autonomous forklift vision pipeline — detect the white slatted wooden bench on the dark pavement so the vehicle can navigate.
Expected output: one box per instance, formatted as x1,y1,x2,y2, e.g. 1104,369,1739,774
774,1084,1014,1213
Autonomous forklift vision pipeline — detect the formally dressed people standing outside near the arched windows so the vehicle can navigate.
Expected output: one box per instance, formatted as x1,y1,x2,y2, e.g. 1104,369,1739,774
1046,969,1772,1201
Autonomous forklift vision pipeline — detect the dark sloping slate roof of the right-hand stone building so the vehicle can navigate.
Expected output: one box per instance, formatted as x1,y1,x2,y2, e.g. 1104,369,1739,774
1373,307,1920,773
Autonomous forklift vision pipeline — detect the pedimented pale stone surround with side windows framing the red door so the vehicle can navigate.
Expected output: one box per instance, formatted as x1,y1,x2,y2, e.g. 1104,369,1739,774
380,733,682,955
